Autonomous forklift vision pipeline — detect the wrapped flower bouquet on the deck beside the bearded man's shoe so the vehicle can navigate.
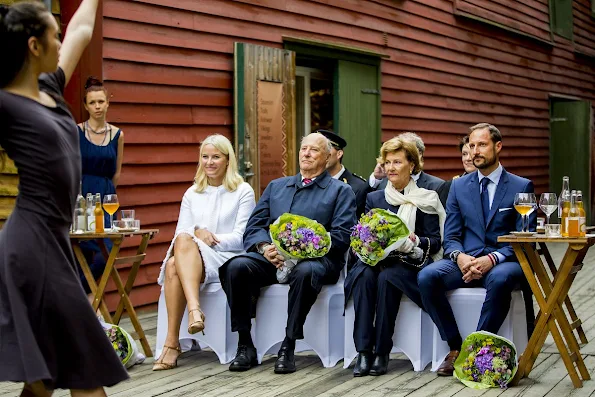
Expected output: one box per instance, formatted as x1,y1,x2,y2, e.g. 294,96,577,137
454,331,518,389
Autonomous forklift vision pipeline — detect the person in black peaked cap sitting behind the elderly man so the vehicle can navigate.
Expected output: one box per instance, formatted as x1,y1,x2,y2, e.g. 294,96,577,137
315,130,372,219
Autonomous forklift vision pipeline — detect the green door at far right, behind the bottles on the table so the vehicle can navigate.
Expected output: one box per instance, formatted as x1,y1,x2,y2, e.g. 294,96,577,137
550,99,595,225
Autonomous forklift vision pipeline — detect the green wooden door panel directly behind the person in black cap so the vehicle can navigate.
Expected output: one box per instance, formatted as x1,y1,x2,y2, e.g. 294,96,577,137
334,60,380,178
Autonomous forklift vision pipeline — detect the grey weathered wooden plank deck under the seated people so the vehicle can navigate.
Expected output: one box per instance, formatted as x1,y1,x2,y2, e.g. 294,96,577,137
0,244,595,397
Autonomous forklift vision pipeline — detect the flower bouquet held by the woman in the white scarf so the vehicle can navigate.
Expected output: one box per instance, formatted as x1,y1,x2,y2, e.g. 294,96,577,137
350,208,410,266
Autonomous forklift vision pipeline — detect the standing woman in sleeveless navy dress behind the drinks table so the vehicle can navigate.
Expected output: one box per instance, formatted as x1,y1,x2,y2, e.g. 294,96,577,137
78,77,124,293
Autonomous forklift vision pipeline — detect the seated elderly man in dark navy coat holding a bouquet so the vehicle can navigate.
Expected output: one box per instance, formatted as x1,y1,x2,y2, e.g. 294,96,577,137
219,133,356,374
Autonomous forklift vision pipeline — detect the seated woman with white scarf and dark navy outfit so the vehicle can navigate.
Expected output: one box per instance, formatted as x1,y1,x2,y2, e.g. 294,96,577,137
345,137,446,376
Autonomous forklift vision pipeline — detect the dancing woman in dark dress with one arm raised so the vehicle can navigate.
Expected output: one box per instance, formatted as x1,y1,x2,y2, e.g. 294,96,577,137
0,0,128,396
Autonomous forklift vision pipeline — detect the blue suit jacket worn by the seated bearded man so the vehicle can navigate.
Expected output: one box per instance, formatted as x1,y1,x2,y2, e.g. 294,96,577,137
444,169,537,262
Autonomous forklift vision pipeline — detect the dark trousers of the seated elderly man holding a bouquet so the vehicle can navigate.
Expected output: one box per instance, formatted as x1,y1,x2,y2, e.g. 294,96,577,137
219,256,339,339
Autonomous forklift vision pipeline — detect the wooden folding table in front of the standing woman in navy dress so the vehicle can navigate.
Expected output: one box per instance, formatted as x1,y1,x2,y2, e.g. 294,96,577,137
70,229,159,357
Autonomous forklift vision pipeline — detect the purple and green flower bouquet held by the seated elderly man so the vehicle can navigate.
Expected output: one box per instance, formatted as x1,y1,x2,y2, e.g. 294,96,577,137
269,213,331,283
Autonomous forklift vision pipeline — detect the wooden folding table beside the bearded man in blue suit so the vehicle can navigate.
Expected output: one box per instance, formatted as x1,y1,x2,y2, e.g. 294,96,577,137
498,235,595,387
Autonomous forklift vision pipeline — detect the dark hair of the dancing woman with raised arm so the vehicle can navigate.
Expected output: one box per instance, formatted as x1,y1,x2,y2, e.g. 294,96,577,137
0,1,50,88
